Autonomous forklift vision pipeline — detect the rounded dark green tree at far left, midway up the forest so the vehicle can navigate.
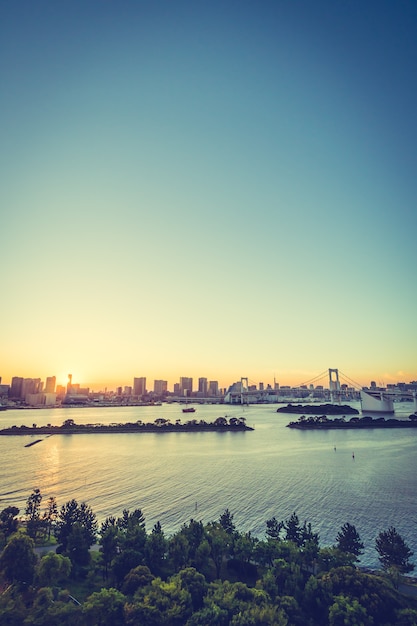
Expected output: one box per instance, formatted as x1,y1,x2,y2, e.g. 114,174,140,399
0,534,36,585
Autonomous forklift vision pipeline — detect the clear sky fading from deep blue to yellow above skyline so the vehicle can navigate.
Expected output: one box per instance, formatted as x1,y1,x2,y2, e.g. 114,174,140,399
0,0,417,388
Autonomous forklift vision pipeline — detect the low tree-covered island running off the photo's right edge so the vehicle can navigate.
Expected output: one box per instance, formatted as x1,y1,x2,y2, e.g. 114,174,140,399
287,413,417,430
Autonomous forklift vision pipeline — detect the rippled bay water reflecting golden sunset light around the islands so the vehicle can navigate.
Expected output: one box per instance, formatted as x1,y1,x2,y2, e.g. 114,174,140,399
0,404,417,566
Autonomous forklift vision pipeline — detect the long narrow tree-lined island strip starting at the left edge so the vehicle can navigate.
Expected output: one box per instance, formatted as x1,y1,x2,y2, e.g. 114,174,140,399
0,417,253,436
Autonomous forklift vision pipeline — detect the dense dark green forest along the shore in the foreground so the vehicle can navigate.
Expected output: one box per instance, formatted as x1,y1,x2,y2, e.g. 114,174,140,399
0,489,417,626
